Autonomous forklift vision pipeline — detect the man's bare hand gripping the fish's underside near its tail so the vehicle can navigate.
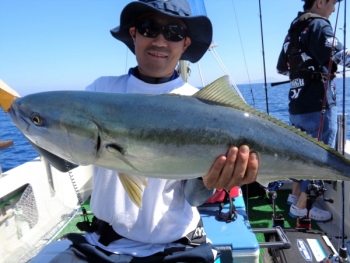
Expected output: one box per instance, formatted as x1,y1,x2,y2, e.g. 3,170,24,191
203,145,259,190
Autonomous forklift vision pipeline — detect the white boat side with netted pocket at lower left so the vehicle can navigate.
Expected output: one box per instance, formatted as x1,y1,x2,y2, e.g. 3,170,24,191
0,158,92,263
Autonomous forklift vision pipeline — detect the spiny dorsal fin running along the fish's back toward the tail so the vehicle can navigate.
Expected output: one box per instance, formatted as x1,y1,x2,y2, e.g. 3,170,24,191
192,76,344,158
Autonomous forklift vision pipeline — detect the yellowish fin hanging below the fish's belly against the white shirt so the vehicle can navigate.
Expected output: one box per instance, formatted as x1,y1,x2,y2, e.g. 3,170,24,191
118,173,147,209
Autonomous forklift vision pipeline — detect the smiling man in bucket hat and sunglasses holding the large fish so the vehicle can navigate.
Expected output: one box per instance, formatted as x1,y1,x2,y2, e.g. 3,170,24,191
30,0,258,263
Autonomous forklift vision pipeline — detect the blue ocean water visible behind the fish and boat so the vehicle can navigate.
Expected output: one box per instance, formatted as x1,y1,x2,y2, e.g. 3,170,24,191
0,78,350,171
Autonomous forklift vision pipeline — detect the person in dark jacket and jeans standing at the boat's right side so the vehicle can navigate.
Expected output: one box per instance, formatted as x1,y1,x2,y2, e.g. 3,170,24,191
277,0,350,222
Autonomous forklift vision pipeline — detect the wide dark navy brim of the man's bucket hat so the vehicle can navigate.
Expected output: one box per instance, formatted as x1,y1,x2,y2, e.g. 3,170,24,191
110,2,213,63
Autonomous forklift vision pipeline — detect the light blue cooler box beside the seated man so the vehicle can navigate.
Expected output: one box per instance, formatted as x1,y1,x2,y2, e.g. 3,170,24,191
198,201,259,263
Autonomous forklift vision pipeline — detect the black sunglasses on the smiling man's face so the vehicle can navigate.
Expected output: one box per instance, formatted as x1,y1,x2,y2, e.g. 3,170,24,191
136,19,187,42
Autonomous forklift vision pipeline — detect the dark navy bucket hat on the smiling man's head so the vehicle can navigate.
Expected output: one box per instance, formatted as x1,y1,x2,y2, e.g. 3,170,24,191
110,0,213,63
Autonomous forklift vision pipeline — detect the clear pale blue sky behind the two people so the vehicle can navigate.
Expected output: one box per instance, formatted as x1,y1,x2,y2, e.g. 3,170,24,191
0,0,350,96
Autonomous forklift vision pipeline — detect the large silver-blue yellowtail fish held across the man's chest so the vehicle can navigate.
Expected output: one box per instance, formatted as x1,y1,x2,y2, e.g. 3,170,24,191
2,77,350,206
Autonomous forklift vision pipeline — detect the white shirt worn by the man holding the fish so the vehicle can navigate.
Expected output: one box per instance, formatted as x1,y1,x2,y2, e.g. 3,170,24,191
86,75,213,257
